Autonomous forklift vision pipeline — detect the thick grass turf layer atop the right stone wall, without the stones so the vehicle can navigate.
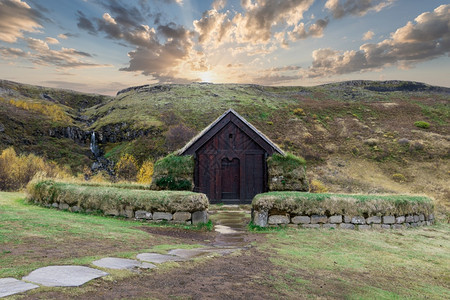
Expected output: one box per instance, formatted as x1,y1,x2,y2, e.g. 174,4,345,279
252,192,434,217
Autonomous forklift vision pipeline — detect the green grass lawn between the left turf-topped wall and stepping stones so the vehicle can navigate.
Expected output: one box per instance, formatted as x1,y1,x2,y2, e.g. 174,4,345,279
0,192,199,278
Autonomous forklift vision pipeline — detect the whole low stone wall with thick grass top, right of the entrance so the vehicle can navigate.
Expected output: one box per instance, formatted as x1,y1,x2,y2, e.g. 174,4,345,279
252,192,434,230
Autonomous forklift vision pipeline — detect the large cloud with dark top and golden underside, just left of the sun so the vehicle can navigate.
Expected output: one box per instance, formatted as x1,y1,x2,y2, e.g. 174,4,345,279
78,0,208,82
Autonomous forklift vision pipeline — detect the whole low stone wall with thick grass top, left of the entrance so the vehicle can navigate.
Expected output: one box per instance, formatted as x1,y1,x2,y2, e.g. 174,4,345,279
27,180,209,224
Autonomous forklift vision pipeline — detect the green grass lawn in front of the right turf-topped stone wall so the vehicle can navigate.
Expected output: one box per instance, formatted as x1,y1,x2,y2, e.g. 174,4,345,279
262,224,450,299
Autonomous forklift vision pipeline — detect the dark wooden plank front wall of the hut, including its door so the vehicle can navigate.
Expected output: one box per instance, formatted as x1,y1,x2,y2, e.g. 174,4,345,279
195,116,267,203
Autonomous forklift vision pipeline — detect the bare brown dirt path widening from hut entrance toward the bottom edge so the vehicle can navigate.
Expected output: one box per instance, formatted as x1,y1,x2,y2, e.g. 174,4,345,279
18,212,283,299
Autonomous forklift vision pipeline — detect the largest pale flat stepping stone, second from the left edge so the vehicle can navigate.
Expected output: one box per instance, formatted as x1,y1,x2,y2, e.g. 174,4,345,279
22,266,108,286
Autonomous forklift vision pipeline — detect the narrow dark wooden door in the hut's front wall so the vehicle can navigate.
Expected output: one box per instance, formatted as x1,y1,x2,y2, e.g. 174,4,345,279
220,158,240,200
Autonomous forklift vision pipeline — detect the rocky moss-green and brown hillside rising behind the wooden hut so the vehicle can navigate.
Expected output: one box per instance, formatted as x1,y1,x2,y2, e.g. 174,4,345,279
0,81,450,209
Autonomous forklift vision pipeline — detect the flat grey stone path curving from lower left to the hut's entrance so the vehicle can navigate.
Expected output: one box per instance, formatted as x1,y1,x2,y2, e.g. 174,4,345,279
0,212,245,298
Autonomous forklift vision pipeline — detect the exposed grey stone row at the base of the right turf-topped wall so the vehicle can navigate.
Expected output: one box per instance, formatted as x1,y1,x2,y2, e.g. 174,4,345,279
252,211,435,230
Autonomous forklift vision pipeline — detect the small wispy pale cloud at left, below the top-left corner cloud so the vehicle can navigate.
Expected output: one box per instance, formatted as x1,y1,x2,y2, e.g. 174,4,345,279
26,38,110,69
